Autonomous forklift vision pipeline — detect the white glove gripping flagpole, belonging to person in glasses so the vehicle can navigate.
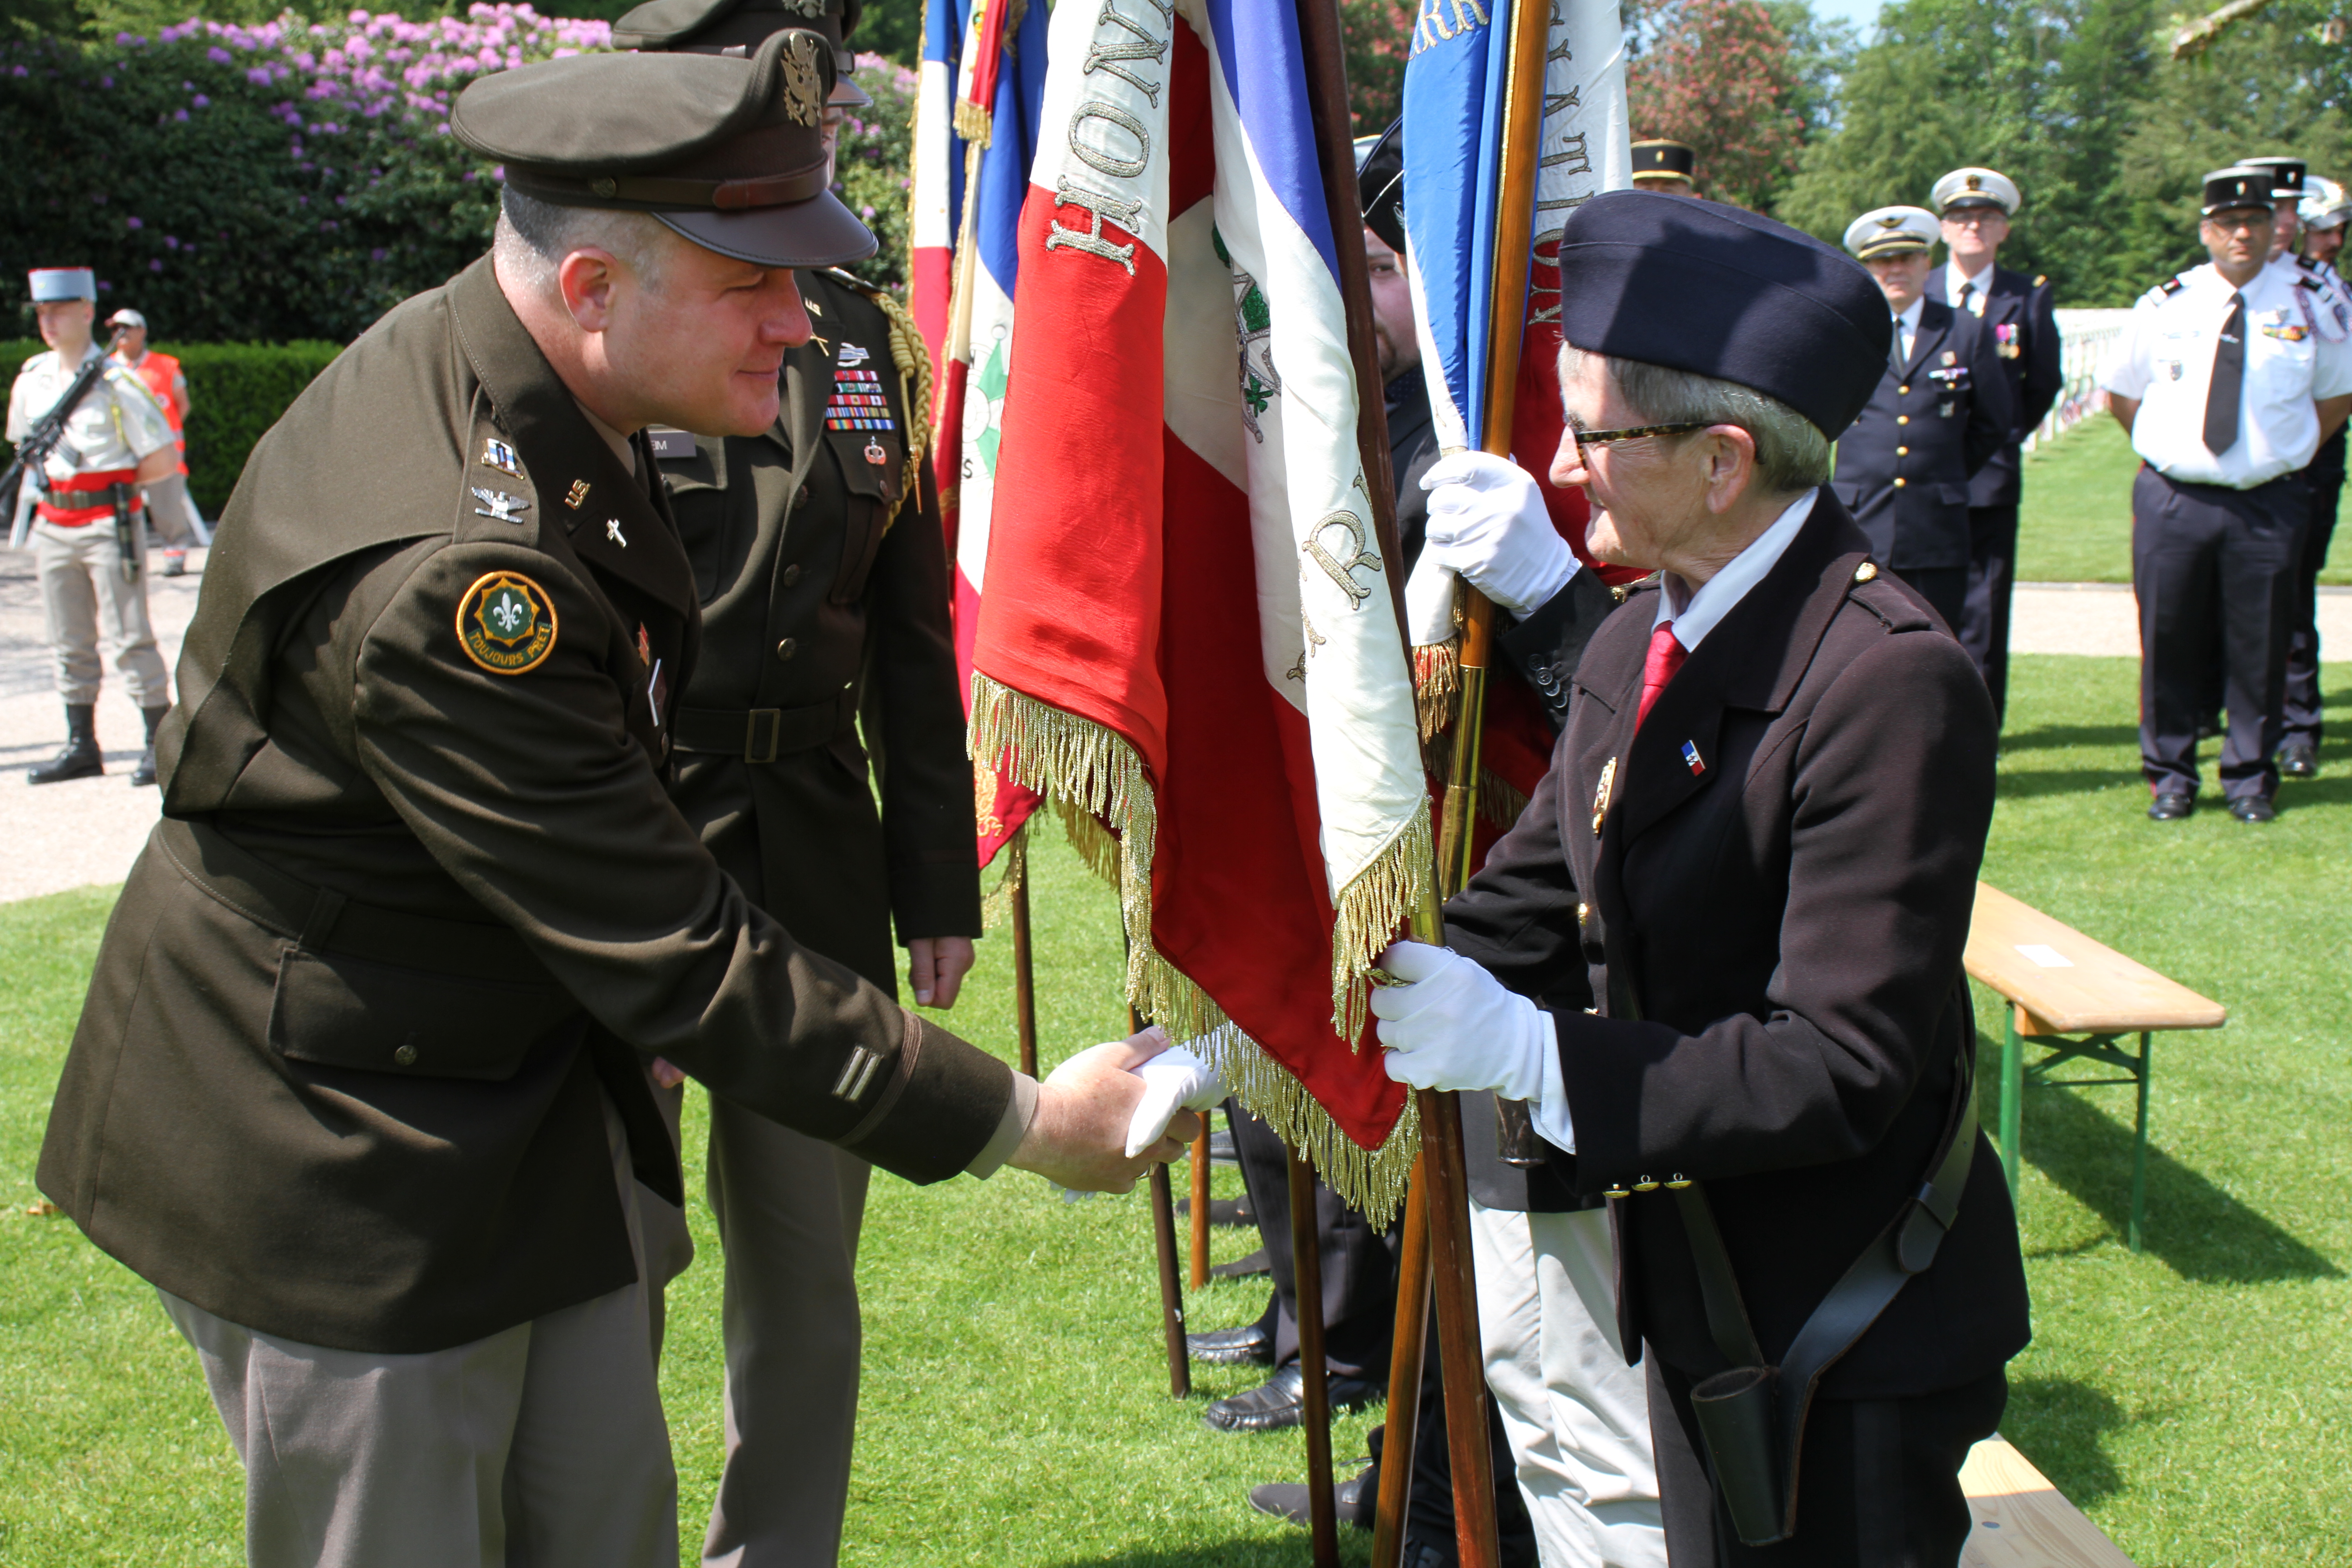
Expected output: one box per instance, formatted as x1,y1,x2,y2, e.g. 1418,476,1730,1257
1371,943,1576,1154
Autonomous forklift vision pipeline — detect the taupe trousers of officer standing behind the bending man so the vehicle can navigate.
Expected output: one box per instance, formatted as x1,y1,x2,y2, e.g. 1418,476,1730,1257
703,1096,872,1568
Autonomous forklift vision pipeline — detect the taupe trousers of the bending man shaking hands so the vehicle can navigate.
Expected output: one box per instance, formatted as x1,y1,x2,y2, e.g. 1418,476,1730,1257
162,1105,677,1568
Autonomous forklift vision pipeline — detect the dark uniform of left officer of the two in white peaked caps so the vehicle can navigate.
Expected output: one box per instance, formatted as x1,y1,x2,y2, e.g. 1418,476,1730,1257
1830,299,2011,627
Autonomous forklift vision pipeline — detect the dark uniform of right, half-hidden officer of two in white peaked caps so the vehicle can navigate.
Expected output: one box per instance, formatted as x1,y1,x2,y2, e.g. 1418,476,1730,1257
1926,265,2065,715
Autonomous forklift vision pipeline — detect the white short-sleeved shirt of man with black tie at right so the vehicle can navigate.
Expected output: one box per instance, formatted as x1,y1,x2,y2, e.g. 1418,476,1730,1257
2105,261,2352,489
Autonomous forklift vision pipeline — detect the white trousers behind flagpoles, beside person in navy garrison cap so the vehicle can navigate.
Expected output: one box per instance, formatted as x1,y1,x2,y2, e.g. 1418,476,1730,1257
1470,1204,1665,1568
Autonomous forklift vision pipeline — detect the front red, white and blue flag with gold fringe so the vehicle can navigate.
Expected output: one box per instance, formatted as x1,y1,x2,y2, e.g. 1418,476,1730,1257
967,0,1430,1213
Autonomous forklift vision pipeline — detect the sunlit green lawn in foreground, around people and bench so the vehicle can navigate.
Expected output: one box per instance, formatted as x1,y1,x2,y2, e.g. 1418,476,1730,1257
0,658,2352,1568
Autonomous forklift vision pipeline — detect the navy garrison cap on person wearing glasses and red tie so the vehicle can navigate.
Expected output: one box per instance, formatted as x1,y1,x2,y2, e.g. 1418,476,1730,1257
1559,191,1893,440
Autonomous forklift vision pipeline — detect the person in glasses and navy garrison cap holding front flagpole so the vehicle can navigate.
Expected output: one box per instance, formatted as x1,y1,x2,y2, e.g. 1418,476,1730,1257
1371,191,2028,1568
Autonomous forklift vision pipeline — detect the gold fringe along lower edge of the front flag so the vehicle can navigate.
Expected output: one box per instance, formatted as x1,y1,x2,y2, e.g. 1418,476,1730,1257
971,672,1432,1225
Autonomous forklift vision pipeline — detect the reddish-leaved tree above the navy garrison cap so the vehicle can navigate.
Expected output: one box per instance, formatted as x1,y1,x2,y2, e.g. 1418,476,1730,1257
1625,0,1820,209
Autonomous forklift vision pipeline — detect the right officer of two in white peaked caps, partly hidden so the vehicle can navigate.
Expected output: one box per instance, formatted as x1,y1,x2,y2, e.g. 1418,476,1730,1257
1926,169,2065,715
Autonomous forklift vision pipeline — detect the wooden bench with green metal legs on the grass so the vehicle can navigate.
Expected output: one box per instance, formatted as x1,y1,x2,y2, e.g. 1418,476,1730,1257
1966,882,2230,1251
